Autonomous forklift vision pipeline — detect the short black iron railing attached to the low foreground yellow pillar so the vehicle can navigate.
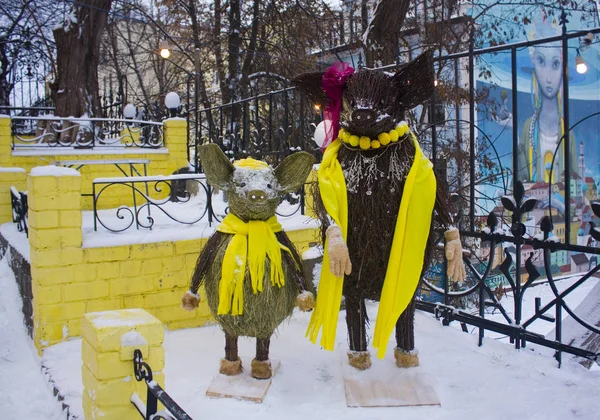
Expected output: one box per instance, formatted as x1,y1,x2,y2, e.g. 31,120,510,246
131,349,192,420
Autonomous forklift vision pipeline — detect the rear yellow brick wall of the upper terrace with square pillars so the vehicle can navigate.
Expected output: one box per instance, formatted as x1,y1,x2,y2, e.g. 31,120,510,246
0,116,188,210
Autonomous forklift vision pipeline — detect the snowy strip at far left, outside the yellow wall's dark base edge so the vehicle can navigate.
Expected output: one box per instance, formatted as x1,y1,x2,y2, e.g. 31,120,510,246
0,256,65,420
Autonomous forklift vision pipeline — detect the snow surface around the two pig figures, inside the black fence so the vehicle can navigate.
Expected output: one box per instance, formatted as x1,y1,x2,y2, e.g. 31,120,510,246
44,304,600,420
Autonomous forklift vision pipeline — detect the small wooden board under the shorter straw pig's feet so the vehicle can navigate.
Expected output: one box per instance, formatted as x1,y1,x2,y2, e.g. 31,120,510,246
206,360,281,403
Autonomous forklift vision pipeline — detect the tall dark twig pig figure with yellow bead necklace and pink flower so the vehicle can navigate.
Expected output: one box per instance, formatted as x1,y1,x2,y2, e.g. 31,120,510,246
293,53,465,370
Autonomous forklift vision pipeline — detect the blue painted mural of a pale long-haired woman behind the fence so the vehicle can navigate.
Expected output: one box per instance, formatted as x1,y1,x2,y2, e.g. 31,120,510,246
477,4,600,282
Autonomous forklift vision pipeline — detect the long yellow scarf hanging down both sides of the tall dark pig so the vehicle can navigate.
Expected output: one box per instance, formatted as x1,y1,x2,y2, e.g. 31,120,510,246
306,134,436,359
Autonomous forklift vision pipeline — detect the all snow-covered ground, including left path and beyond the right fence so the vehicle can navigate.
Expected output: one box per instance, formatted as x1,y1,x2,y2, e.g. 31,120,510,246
0,231,600,420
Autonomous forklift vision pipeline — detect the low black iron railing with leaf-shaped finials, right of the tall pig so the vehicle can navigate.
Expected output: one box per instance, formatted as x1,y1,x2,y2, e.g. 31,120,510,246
417,182,600,364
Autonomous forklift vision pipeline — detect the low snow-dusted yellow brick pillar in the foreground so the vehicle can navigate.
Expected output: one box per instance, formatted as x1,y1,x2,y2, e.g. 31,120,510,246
81,309,165,419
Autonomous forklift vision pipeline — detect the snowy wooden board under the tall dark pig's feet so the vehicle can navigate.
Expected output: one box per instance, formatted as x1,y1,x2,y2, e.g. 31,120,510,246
343,360,440,407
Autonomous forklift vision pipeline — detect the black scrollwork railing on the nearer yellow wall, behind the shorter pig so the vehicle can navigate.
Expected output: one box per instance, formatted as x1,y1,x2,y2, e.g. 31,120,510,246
92,174,305,232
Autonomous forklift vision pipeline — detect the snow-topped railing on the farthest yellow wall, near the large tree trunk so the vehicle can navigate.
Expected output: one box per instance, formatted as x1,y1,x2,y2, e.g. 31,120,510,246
11,115,164,150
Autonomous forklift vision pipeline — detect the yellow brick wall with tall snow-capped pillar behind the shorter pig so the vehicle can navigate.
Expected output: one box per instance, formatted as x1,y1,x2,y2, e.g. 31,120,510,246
27,169,317,351
